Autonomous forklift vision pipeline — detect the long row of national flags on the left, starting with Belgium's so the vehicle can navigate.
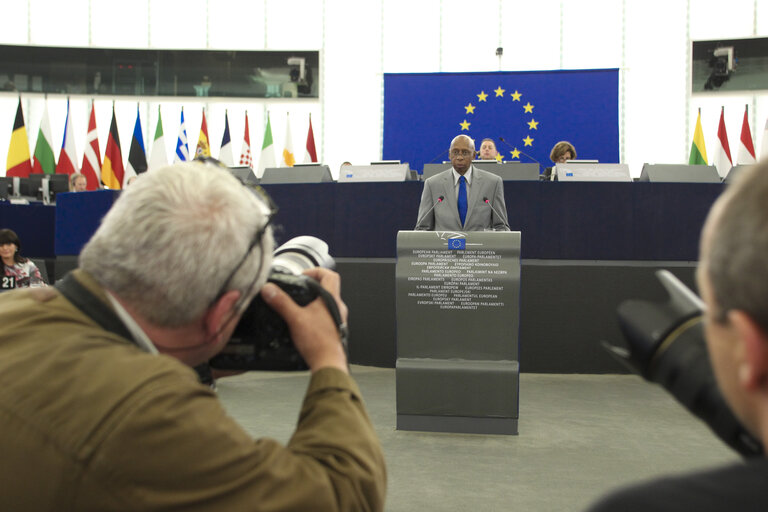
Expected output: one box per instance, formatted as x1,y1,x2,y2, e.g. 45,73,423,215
6,98,317,190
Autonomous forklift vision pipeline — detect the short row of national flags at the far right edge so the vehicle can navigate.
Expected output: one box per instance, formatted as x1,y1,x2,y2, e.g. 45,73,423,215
688,105,768,178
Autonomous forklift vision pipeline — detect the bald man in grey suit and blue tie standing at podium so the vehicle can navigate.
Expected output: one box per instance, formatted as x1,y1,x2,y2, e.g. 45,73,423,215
414,135,510,231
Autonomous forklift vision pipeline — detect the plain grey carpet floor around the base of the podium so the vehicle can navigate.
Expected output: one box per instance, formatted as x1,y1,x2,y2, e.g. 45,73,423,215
218,366,738,512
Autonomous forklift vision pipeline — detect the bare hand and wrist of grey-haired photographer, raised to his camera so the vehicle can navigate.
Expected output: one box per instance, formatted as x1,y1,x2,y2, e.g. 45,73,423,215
261,268,348,373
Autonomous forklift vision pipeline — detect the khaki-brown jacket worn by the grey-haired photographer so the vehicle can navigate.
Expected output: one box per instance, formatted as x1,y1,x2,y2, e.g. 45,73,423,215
0,272,386,512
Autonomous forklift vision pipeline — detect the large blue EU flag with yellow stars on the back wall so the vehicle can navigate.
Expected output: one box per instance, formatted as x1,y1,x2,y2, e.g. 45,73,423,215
382,69,619,171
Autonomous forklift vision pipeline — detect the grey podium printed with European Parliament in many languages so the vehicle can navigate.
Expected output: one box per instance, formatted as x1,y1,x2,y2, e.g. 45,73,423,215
395,231,520,434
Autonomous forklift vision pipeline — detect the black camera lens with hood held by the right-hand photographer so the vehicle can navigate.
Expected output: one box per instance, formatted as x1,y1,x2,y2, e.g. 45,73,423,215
603,270,763,457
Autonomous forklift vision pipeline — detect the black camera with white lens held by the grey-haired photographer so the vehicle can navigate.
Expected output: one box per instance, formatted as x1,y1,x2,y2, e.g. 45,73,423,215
210,236,346,371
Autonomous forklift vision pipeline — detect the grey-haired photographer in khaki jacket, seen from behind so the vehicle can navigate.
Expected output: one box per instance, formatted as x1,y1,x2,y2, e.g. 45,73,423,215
0,162,386,511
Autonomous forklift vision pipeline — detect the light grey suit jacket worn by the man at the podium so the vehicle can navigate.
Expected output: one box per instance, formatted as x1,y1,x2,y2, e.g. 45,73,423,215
414,167,509,231
